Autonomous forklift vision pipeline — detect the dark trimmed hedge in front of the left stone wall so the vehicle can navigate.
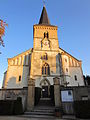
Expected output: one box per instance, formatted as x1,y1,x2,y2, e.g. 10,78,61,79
0,99,23,115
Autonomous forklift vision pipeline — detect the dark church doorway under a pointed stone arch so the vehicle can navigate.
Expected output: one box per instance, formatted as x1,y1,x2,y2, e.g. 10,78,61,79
40,78,50,98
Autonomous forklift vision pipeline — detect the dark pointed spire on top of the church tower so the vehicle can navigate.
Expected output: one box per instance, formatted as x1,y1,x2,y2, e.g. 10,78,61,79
39,5,50,25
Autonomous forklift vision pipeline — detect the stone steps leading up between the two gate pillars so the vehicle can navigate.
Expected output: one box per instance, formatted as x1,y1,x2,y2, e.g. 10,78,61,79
23,98,55,118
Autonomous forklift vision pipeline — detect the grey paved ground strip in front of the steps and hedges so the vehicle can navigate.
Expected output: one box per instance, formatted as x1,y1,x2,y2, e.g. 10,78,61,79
0,116,90,120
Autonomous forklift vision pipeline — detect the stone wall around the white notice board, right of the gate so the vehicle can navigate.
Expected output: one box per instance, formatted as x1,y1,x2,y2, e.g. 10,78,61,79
61,86,90,114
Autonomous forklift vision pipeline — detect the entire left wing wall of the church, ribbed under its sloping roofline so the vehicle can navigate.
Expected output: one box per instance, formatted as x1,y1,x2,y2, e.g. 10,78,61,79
4,50,31,88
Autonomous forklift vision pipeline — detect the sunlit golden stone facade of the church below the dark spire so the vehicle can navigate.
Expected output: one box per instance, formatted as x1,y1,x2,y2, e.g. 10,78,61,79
3,25,84,88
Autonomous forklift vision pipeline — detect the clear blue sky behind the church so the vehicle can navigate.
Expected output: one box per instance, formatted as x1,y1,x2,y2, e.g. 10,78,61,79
0,0,90,87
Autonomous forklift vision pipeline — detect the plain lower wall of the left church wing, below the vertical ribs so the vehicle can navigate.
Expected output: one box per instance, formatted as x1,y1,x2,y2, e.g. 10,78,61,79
5,66,29,88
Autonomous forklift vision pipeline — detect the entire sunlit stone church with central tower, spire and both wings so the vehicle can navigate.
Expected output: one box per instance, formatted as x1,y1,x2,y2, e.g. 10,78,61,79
2,6,84,110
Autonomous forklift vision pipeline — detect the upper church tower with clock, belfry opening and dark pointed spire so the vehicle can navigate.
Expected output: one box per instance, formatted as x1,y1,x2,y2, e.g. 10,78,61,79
33,6,59,50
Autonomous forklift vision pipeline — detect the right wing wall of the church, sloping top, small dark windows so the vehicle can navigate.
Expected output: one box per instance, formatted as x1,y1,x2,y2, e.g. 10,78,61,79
61,49,84,86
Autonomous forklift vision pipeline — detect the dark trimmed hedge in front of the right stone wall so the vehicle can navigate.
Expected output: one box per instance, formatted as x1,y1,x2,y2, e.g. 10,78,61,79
74,100,90,119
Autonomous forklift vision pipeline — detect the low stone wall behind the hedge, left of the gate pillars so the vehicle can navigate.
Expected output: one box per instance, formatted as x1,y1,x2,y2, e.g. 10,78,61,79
0,88,27,111
